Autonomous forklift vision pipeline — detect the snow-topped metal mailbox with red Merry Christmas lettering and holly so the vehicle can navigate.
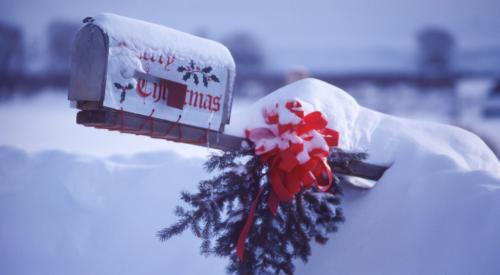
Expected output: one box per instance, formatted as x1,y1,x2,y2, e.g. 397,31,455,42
68,14,240,147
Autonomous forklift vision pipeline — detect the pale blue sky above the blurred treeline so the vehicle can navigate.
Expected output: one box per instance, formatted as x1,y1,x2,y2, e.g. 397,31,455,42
0,0,500,50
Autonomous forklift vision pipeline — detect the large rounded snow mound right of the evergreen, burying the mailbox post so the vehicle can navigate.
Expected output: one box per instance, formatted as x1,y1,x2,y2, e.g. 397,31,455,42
228,79,500,274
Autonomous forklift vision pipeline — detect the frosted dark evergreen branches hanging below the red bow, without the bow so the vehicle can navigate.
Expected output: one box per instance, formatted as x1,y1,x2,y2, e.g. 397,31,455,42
158,148,358,274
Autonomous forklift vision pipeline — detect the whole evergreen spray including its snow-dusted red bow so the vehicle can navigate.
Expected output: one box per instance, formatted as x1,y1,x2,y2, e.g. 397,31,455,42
158,100,366,274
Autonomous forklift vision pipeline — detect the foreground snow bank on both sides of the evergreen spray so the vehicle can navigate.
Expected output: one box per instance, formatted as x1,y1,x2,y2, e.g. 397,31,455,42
0,79,500,275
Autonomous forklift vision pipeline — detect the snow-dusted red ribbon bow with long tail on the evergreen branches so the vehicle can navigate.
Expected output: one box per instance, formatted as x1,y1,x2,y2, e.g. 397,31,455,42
236,100,339,260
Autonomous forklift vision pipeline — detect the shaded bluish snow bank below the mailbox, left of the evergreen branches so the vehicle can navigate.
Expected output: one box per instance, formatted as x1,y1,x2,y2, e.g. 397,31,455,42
0,146,225,275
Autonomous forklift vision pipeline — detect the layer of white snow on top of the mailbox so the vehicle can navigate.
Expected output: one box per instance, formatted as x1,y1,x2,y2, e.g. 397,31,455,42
93,13,235,71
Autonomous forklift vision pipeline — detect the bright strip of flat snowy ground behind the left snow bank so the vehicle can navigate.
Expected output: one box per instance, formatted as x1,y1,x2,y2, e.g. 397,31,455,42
0,91,207,160
